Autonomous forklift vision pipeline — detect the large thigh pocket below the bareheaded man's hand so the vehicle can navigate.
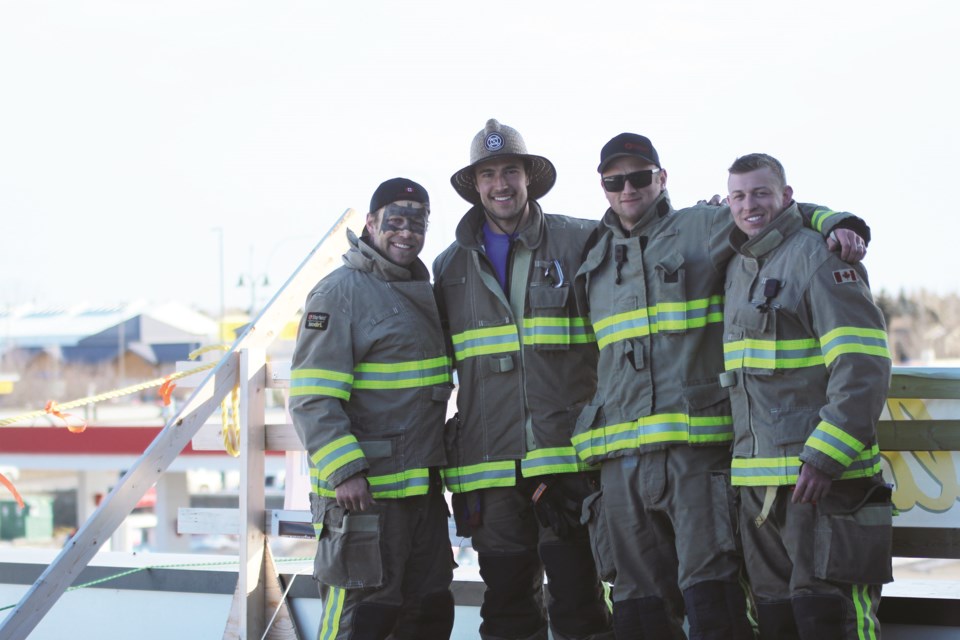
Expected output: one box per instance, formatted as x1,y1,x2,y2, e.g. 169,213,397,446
813,485,893,585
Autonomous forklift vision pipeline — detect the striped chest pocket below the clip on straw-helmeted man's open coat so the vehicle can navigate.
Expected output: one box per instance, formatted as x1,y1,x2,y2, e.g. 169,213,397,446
523,286,572,351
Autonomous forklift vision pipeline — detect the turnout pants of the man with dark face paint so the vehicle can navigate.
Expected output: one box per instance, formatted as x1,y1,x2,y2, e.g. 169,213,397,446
311,476,454,640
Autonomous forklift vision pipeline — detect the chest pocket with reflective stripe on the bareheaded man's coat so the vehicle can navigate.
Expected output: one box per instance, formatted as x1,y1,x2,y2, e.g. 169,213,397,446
723,307,779,376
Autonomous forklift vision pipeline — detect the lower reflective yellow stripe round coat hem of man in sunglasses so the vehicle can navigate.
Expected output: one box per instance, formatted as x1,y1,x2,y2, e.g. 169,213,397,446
573,413,733,460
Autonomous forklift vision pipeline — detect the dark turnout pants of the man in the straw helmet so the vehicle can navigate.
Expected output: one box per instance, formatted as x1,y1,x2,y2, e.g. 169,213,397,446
473,478,613,640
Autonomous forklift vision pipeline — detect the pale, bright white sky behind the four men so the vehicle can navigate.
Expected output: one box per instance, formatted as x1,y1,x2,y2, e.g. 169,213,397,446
0,0,960,314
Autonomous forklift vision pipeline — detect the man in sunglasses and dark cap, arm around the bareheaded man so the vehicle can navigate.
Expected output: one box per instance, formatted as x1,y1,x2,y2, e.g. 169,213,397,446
573,133,866,640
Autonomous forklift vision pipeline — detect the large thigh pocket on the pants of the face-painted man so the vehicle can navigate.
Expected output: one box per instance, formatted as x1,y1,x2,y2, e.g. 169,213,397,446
313,498,383,589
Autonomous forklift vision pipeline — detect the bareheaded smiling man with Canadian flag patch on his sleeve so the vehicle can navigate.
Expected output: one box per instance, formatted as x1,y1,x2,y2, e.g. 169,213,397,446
721,153,893,640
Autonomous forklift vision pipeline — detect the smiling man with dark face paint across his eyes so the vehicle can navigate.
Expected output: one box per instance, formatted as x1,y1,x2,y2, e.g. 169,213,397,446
290,178,453,640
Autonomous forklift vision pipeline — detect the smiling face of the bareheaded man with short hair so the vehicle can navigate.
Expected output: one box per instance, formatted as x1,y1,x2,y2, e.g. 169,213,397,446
727,167,793,238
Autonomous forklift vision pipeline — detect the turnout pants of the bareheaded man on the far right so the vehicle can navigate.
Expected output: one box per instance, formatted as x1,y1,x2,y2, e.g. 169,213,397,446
738,478,892,640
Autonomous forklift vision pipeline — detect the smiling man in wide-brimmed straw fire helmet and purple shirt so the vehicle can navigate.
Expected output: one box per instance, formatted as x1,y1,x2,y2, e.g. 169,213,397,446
433,120,613,640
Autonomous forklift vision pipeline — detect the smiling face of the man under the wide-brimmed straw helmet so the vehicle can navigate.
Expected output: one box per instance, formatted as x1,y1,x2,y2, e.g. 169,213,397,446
473,157,530,233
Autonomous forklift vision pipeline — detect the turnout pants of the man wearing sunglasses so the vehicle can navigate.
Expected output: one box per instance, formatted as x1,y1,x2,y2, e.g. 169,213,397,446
601,445,753,640
